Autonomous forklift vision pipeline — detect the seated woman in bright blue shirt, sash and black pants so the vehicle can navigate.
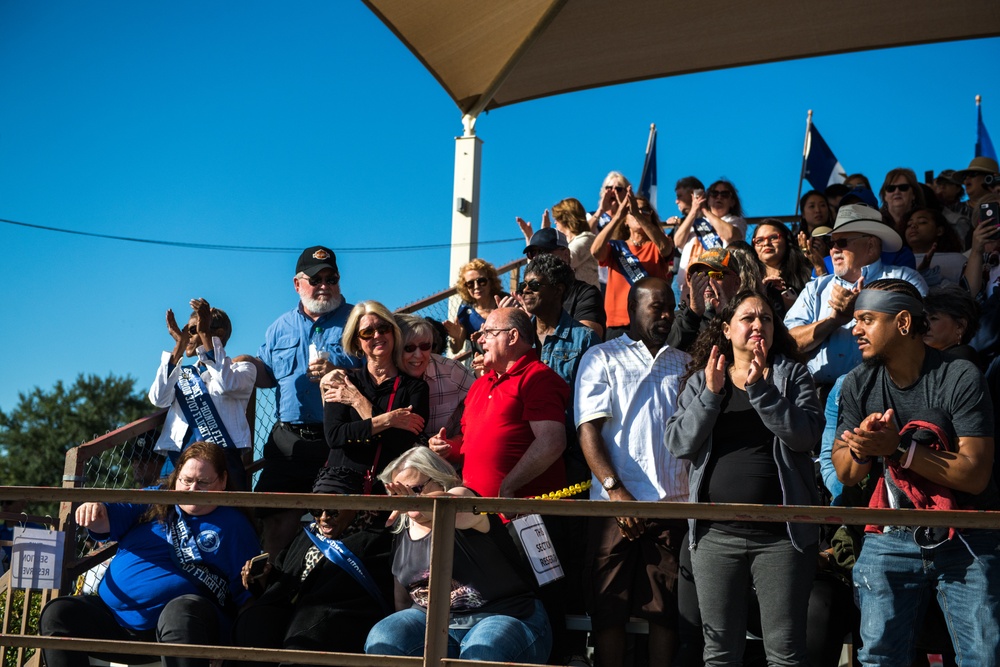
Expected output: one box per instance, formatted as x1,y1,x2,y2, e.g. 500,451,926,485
39,442,260,667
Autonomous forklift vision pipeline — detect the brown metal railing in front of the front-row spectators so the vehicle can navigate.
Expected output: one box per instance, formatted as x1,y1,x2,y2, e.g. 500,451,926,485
0,487,1000,667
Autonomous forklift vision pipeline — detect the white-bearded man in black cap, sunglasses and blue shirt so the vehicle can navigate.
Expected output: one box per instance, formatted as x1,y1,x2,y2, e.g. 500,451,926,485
254,246,359,560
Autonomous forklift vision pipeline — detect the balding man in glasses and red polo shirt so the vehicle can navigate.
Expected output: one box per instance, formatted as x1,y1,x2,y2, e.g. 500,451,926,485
430,308,569,498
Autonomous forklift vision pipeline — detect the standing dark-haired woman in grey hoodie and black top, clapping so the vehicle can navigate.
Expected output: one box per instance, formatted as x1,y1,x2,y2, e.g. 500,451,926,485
665,291,823,665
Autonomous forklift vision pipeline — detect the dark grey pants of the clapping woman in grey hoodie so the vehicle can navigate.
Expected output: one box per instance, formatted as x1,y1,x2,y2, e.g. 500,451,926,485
691,528,816,667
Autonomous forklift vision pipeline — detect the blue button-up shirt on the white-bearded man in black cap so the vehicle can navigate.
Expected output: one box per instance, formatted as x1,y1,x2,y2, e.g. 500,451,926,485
257,301,361,424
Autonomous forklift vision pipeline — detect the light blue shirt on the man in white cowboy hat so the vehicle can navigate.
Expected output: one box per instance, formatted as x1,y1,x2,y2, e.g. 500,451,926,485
785,260,927,384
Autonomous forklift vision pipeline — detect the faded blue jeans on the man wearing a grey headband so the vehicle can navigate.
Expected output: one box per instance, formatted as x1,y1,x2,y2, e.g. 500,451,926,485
854,530,1000,667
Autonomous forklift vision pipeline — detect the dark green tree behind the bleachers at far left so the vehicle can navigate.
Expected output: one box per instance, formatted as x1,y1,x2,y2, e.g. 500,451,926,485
0,374,148,486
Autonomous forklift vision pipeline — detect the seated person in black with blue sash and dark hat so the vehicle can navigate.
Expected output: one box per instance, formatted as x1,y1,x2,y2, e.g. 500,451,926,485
233,468,393,667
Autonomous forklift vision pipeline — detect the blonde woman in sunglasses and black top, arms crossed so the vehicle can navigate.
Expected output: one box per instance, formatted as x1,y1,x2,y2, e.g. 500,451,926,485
320,301,429,493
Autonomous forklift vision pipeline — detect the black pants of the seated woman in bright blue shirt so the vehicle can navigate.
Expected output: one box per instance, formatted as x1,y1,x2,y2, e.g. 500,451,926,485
39,595,221,667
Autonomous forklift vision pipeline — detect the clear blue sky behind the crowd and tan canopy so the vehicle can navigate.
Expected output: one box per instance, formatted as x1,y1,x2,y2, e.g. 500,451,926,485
0,0,1000,418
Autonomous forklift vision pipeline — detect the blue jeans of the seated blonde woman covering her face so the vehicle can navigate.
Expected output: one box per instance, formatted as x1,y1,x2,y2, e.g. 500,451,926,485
365,600,552,665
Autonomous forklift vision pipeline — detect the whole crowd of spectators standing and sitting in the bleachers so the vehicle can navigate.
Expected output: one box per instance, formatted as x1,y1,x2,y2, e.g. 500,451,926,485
41,158,1000,667
